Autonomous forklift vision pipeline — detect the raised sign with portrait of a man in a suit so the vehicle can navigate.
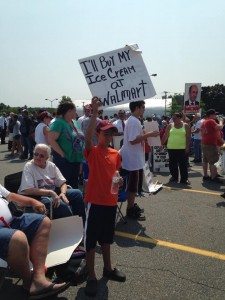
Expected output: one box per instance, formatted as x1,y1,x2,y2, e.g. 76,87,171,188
184,83,201,113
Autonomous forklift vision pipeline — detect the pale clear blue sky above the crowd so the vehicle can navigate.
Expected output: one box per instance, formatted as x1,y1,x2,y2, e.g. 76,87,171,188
0,0,225,106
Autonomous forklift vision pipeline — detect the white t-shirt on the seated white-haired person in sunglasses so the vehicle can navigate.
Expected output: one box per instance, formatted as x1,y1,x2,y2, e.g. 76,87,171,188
18,160,66,194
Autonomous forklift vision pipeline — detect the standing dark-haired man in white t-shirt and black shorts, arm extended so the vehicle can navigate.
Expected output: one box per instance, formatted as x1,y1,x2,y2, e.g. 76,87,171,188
120,100,159,220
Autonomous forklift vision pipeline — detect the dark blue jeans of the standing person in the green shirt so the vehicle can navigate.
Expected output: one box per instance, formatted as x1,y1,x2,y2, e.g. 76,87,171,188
52,151,80,189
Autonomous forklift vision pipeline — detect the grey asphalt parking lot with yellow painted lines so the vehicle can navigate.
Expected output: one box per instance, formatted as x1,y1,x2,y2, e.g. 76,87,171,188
0,145,225,300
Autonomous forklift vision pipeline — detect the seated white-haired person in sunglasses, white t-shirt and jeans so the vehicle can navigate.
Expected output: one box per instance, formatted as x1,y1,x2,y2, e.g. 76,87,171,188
19,144,85,222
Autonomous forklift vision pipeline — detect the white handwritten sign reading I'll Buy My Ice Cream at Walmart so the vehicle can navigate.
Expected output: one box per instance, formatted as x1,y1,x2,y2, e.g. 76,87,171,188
79,45,156,107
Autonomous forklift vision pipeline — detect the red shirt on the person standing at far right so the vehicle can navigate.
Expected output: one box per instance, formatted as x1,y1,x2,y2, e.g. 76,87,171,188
201,119,218,145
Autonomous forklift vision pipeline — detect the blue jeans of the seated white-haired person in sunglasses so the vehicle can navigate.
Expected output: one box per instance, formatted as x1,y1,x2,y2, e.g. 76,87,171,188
40,189,85,223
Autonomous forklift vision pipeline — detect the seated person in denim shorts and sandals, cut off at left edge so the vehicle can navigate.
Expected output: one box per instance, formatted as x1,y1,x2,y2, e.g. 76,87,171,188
0,184,67,299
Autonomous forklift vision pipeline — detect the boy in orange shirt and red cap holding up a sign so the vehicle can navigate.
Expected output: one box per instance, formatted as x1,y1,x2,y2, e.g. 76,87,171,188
84,97,126,297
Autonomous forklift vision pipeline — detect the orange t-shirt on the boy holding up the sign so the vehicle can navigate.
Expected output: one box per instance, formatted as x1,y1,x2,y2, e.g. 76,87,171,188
84,146,121,206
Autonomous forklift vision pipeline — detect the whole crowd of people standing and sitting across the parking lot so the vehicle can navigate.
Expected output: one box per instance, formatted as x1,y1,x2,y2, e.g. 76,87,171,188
0,97,224,298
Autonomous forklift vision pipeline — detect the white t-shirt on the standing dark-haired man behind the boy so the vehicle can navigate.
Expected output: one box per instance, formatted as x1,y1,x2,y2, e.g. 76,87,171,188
120,116,145,171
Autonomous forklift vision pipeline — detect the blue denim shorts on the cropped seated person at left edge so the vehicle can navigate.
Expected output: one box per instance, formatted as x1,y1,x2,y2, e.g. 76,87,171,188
0,213,45,260
